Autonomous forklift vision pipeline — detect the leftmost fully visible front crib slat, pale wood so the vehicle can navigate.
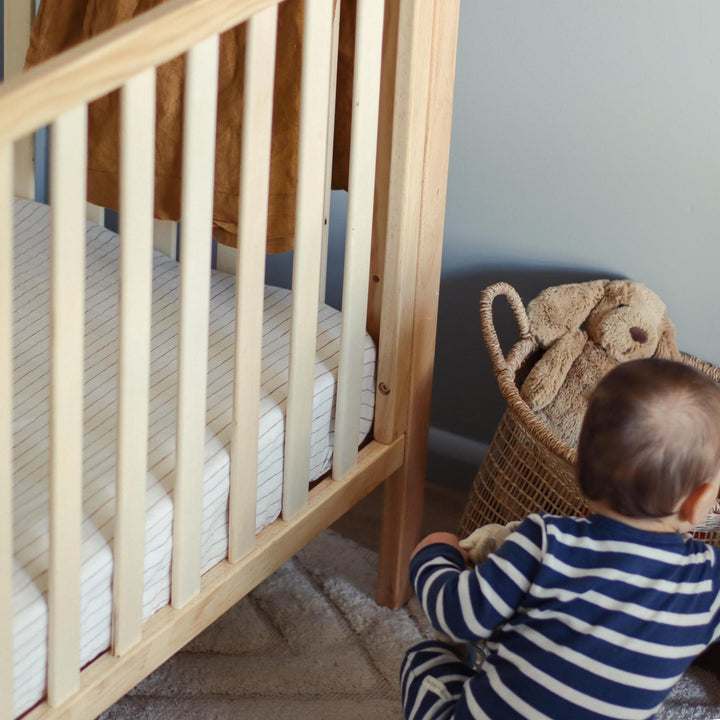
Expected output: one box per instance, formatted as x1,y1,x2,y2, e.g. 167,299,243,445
48,106,87,706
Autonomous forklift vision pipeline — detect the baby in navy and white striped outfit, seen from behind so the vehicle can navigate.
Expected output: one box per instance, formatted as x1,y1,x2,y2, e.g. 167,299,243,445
401,358,720,720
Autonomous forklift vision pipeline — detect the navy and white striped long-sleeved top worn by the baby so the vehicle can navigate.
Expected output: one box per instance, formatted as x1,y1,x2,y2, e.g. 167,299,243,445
410,515,720,720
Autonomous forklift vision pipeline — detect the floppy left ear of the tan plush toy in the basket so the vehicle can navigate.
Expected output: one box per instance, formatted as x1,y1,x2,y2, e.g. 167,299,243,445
527,280,609,347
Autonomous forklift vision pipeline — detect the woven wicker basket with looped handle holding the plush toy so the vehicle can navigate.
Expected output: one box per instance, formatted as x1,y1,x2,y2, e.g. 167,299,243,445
459,283,720,545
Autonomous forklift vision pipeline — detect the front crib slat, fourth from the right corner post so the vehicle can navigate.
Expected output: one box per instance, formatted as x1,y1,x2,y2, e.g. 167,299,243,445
172,35,219,608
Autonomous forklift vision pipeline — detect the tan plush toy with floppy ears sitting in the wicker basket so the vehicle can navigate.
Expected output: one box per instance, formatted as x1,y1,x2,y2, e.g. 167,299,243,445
520,280,680,446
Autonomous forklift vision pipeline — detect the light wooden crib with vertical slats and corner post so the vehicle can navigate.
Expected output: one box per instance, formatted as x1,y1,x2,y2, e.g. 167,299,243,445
0,0,458,720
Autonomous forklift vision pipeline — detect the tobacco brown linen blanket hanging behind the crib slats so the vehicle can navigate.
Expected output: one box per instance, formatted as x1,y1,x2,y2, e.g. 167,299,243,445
26,0,356,252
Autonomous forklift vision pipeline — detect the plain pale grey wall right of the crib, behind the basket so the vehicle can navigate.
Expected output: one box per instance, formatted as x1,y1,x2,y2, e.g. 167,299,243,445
429,0,720,485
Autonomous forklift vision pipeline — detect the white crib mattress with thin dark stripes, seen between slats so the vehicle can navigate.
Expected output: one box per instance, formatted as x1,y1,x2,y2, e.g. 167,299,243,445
13,195,376,715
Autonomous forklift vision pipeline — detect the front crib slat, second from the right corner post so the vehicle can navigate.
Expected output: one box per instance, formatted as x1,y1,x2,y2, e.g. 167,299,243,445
283,0,333,520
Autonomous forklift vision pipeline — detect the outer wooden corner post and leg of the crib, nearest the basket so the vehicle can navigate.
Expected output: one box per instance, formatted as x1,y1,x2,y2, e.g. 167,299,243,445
377,0,460,607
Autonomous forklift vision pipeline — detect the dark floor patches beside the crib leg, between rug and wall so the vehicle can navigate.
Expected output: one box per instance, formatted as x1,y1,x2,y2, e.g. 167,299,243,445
332,483,467,552
